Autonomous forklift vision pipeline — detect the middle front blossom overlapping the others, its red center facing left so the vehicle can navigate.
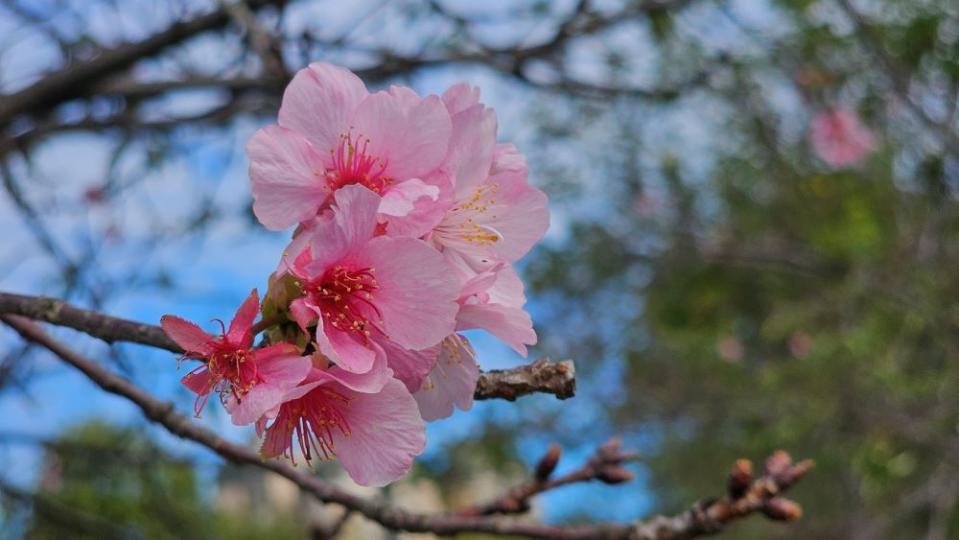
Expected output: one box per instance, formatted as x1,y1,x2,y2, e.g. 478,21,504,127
289,185,459,373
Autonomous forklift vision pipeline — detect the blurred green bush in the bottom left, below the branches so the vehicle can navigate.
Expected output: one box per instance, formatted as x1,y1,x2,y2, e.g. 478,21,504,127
28,422,303,540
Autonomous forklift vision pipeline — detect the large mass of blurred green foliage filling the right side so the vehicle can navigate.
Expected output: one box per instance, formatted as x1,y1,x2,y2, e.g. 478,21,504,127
528,1,959,538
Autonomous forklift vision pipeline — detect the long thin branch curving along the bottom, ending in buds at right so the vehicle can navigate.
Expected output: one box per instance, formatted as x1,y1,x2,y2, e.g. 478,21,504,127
0,315,811,540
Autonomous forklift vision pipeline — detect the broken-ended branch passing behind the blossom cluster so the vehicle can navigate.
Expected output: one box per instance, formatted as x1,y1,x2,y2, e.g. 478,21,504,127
0,292,576,401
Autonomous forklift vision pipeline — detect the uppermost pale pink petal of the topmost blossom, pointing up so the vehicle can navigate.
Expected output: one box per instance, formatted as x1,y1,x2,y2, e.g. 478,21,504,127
279,62,369,155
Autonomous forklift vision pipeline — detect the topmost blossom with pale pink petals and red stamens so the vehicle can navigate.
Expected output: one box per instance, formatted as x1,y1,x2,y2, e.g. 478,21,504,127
247,63,452,234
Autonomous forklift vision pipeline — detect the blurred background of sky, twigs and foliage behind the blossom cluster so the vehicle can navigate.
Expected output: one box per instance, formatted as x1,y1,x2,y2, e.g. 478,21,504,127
0,0,959,540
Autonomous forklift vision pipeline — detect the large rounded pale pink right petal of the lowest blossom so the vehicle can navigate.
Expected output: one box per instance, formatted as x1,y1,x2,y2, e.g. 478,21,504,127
333,379,426,486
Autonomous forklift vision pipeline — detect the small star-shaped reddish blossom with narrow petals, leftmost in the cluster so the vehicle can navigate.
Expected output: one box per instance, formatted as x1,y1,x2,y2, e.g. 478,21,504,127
160,289,311,425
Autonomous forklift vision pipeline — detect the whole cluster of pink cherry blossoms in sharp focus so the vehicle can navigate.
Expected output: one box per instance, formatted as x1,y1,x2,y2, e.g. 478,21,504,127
162,63,549,485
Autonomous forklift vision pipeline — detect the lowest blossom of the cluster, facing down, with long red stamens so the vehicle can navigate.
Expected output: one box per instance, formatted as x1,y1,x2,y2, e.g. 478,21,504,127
257,366,426,486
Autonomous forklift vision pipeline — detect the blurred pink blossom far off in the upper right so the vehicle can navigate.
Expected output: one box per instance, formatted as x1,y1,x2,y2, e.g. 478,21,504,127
810,108,876,167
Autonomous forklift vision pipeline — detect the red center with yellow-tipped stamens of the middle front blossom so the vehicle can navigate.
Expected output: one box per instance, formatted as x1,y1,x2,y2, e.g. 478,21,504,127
306,266,381,342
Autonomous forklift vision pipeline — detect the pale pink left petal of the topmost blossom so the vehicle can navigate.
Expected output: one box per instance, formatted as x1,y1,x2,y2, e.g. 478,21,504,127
246,126,329,230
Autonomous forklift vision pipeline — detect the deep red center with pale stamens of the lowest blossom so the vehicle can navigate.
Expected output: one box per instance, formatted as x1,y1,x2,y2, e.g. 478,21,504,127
277,386,351,465
